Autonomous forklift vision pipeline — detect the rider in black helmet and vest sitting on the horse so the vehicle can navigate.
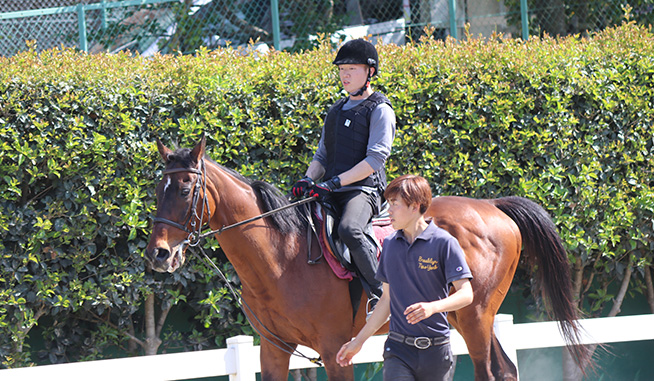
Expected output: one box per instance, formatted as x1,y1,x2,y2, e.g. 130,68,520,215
291,39,395,310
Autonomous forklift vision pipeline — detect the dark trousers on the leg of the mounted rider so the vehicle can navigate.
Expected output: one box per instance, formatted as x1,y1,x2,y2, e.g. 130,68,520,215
331,190,382,297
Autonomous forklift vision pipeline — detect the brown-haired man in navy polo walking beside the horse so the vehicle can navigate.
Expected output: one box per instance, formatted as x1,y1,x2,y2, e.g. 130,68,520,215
336,175,473,381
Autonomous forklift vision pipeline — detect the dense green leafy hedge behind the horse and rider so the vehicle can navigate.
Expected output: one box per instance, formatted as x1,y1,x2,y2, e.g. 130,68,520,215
0,24,654,366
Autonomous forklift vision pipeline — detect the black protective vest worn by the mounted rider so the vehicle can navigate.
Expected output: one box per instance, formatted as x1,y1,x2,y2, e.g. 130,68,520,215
324,92,392,192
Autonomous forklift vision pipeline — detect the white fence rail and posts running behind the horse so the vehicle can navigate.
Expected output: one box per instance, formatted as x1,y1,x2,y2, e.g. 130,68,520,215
0,314,654,381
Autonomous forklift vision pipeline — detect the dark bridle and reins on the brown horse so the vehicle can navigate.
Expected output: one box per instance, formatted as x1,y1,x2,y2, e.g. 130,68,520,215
152,159,323,366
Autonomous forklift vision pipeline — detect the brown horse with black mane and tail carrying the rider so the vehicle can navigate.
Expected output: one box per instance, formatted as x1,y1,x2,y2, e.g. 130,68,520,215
145,137,585,380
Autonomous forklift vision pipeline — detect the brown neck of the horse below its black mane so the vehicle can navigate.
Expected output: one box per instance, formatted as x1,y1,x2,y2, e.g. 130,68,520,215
207,163,298,284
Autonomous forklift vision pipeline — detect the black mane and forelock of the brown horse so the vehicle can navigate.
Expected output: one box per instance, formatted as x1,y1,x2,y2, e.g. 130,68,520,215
166,148,307,235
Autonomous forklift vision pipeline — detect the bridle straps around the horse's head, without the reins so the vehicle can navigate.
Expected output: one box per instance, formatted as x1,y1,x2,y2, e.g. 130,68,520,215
152,159,211,246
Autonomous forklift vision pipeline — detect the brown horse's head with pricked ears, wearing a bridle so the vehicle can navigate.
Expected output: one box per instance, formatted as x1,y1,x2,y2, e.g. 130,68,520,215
145,135,210,272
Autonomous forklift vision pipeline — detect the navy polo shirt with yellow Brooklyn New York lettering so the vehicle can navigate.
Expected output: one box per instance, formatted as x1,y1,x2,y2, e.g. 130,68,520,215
376,222,472,337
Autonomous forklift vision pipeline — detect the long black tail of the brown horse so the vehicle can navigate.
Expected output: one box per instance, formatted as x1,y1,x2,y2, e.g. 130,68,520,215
492,196,593,373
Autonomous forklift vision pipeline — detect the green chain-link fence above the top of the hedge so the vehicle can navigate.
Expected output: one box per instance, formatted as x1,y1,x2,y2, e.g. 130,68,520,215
0,0,654,56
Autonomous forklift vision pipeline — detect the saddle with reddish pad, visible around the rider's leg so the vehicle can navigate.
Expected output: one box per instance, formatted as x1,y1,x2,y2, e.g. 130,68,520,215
311,201,393,280
